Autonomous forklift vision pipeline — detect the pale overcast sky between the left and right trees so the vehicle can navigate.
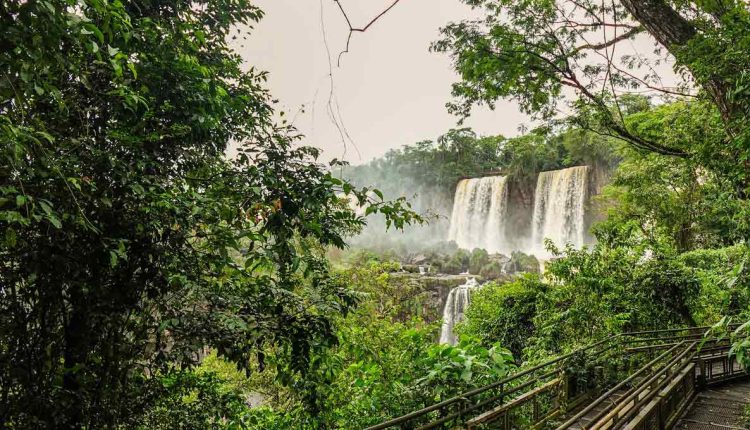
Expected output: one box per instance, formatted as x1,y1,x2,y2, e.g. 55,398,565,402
238,0,529,164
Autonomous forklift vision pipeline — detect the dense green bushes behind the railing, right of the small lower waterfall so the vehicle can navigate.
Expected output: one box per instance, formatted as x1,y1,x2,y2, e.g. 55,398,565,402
533,235,699,354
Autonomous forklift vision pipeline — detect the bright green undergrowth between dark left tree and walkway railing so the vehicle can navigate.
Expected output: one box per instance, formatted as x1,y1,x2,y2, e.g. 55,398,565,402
226,264,512,428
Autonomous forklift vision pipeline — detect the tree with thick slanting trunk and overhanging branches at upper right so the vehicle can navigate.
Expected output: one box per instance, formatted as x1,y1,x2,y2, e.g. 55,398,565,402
433,0,750,168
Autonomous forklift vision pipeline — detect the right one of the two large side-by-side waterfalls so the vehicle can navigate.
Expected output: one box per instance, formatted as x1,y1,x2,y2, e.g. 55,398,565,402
530,166,589,255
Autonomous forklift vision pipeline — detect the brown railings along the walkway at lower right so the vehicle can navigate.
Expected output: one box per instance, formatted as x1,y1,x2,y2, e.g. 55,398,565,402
366,327,747,430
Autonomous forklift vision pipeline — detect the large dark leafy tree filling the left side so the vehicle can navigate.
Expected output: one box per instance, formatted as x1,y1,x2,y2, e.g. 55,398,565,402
0,0,419,428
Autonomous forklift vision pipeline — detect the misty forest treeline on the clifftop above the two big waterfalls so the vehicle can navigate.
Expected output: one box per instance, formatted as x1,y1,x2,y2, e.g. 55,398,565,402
344,126,614,198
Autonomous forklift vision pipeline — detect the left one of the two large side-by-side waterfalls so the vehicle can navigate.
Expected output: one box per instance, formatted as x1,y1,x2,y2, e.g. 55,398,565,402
448,176,510,252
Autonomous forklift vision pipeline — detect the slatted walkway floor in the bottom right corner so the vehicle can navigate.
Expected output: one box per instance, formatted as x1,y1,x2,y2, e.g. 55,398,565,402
675,381,750,430
